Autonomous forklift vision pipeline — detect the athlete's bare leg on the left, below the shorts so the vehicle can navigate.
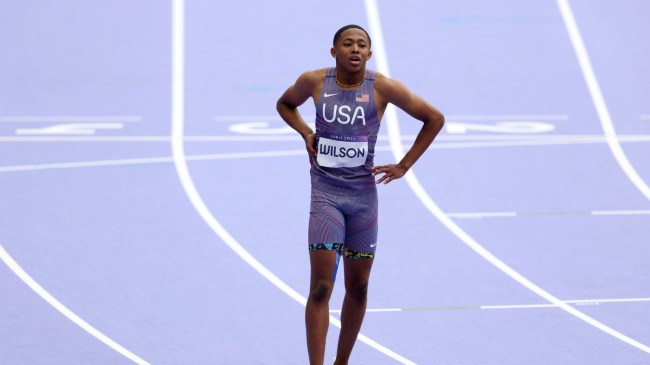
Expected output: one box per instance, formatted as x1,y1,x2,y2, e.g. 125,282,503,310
305,250,336,365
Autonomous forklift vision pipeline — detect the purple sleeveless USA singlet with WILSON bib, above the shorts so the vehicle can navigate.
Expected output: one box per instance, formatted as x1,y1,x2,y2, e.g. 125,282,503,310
311,68,380,195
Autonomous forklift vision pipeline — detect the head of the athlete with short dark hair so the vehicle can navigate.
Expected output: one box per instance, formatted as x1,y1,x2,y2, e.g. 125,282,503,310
331,28,372,72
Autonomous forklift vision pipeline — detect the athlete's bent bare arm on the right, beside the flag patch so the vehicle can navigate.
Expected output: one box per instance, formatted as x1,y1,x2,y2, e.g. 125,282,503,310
373,75,445,184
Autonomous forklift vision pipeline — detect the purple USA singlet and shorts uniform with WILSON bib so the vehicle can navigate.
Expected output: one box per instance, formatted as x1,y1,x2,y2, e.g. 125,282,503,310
309,68,380,258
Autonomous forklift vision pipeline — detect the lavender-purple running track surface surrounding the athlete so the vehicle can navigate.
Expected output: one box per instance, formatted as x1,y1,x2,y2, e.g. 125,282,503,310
0,0,650,365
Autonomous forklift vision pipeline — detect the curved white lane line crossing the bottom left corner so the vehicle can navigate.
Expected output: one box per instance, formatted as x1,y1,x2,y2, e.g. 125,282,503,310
0,244,149,365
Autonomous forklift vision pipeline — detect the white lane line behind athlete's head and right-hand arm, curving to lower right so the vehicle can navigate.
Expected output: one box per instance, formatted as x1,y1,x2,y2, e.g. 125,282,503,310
365,0,650,353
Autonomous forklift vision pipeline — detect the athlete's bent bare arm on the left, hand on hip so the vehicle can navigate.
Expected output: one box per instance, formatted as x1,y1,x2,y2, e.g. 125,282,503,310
276,70,324,156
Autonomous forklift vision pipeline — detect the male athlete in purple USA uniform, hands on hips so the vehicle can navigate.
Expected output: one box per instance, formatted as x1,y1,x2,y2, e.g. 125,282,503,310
277,24,444,365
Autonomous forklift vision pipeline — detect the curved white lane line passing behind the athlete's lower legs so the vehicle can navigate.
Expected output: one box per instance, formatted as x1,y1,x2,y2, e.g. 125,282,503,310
172,0,415,365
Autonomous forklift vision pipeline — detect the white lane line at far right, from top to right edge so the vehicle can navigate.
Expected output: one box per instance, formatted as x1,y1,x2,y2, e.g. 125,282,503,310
557,0,650,200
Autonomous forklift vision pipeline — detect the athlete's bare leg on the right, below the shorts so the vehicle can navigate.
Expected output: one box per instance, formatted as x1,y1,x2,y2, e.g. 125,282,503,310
335,255,374,365
